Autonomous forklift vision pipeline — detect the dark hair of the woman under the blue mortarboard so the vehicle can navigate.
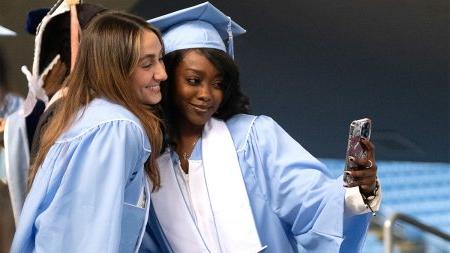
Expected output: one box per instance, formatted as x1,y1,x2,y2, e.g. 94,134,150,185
161,48,250,141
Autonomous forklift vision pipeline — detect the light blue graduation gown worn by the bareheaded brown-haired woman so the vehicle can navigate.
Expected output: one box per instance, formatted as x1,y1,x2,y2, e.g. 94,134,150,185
12,99,150,252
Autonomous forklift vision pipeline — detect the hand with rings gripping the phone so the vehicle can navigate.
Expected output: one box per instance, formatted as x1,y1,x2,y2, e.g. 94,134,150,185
345,138,377,196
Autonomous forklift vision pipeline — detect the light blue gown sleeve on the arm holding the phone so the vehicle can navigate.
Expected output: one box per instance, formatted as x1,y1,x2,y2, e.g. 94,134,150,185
248,116,369,252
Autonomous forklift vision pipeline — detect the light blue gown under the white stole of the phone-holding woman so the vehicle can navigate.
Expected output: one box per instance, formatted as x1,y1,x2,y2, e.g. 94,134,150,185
141,114,370,253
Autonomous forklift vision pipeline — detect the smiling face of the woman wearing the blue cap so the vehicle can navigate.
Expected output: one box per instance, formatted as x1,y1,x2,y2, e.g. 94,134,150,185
172,50,227,128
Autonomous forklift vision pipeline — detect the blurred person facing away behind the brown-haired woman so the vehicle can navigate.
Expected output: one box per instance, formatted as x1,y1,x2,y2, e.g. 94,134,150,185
5,1,105,227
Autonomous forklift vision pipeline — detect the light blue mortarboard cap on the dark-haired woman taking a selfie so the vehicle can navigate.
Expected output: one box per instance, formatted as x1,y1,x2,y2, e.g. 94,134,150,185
148,2,246,57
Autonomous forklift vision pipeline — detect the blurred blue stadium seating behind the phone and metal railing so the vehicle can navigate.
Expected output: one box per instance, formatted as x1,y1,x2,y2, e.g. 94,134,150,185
320,159,450,253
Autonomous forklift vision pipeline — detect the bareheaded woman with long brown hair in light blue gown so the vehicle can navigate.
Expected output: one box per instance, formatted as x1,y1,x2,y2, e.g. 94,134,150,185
12,12,167,252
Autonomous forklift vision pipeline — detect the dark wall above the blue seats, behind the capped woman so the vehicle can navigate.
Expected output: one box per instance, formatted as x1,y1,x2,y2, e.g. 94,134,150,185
130,0,450,162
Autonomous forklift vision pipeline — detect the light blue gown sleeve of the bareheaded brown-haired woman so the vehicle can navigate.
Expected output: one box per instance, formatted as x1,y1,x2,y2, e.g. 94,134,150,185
12,120,146,252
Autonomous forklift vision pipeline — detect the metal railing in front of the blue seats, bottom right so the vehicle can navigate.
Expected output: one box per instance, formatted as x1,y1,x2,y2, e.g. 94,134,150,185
383,213,450,253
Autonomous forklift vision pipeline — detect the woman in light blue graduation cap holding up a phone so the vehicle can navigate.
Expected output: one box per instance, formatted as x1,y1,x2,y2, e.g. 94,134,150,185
142,2,380,253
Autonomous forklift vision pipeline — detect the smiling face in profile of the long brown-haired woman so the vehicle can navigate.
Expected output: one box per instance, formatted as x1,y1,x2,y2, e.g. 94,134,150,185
130,30,167,105
